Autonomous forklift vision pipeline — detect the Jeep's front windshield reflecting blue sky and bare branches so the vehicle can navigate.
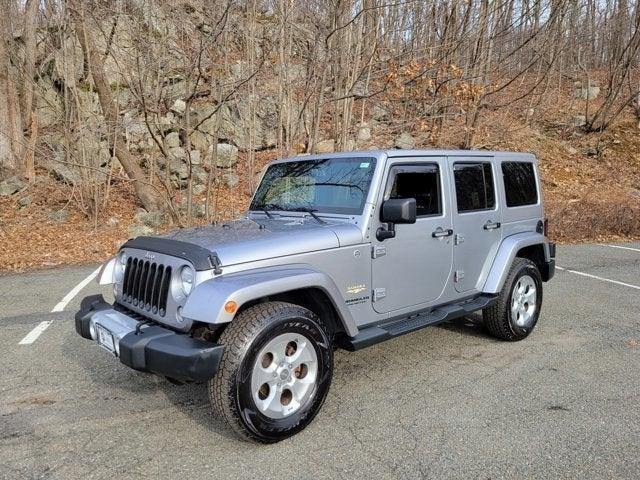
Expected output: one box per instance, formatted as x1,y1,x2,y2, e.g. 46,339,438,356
250,157,376,215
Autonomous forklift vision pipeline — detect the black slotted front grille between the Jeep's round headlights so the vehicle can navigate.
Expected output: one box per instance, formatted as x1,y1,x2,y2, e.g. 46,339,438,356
122,257,171,317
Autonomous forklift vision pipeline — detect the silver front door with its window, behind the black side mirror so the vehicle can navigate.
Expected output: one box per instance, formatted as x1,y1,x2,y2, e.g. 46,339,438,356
372,157,453,313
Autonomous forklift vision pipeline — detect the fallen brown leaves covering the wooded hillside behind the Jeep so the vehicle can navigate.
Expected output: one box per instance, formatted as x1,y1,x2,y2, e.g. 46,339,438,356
0,115,640,272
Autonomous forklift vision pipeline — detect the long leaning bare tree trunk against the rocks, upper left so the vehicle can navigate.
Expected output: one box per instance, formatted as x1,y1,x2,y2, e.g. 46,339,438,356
72,11,160,211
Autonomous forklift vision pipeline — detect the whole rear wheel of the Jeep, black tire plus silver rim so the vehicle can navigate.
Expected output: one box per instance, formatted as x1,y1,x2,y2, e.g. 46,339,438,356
482,258,542,341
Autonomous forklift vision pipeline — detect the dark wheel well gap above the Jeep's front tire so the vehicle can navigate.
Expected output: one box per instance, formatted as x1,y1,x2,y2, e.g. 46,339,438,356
236,287,345,338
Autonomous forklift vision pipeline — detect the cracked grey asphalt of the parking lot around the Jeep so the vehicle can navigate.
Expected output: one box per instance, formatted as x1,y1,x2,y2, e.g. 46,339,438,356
0,243,640,479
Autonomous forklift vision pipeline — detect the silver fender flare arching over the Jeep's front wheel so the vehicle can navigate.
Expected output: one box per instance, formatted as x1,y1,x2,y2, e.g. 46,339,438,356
182,265,358,336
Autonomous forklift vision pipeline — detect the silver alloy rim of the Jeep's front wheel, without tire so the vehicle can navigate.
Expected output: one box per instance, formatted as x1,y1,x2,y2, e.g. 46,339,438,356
251,333,318,418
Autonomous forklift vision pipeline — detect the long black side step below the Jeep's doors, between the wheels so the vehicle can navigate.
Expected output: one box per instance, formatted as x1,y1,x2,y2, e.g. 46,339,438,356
339,295,496,352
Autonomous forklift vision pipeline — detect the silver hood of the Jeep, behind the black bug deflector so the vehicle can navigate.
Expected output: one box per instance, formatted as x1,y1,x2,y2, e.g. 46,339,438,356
162,217,362,266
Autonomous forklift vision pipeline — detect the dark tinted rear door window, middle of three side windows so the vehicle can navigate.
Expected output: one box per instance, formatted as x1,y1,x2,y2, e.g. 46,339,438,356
453,162,496,212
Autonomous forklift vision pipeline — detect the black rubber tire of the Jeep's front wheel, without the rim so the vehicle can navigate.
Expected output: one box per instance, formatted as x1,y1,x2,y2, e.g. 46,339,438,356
208,302,333,443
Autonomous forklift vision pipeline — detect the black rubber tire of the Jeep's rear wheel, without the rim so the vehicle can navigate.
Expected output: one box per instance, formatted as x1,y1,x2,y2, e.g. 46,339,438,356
482,257,542,342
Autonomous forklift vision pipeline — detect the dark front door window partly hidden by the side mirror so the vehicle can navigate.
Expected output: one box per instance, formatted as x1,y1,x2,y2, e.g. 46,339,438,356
386,165,442,217
